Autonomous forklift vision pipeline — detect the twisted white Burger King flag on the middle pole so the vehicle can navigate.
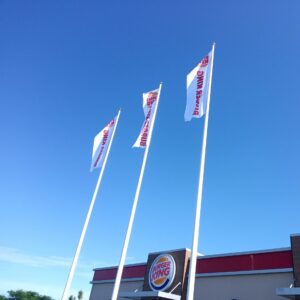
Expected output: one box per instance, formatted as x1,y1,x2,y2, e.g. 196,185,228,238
133,89,158,148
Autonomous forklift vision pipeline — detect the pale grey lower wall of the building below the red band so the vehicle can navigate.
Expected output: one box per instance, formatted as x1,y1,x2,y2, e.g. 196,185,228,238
90,272,293,300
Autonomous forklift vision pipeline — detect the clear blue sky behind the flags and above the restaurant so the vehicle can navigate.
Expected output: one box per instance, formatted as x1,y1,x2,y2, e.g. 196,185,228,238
0,0,300,299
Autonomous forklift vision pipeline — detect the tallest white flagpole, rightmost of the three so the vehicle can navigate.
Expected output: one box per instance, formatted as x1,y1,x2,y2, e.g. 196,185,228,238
186,43,215,300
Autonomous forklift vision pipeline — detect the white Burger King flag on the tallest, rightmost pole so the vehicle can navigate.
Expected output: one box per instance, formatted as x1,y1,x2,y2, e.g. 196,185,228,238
184,52,212,121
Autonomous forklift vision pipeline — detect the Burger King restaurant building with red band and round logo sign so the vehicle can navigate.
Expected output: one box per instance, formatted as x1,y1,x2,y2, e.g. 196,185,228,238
90,234,300,300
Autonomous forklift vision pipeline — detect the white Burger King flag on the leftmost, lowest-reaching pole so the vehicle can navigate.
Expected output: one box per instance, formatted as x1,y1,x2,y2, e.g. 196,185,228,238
91,118,116,172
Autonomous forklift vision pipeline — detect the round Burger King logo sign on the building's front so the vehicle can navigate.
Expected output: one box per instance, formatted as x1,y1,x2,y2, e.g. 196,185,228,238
149,254,176,291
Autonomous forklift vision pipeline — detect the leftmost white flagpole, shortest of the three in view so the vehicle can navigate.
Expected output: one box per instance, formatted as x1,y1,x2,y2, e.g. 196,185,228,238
61,110,121,300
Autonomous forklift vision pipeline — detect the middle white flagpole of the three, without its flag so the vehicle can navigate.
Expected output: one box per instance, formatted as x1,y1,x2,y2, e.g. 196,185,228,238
111,83,162,300
